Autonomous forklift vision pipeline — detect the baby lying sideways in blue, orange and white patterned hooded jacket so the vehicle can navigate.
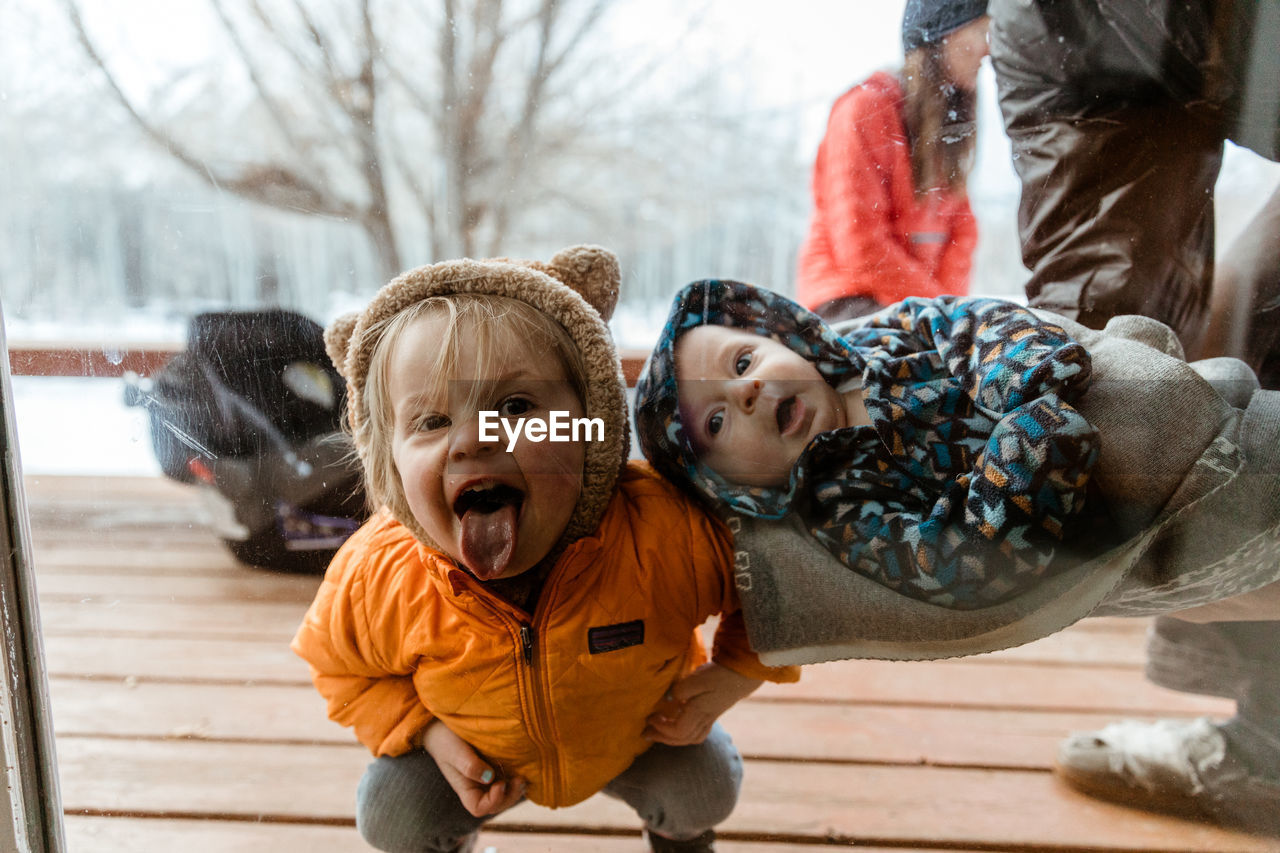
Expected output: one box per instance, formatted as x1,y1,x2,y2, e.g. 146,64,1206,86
636,280,1108,610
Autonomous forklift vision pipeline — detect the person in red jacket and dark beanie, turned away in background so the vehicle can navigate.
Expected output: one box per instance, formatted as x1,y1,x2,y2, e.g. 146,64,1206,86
796,0,987,323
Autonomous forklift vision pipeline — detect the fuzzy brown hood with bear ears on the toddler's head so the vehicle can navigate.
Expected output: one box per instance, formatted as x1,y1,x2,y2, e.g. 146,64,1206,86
325,246,631,547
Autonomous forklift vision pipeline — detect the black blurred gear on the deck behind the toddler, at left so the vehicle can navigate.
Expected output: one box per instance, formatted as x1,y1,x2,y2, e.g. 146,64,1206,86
125,310,367,573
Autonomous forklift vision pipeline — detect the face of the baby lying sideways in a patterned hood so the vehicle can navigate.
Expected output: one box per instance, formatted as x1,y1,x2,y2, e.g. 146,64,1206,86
676,325,847,487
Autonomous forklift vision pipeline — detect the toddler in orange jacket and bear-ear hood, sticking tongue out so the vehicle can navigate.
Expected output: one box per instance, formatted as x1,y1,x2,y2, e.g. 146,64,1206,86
293,247,797,850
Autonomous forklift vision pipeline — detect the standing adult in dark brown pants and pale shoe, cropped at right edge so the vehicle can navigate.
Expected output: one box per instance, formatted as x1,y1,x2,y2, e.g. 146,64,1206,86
991,0,1280,831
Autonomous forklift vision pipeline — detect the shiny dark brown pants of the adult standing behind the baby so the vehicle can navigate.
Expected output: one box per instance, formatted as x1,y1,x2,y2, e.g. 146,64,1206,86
991,0,1280,346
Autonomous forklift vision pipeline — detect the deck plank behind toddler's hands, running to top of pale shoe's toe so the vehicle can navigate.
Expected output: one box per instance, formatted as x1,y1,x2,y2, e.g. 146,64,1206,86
50,678,1198,770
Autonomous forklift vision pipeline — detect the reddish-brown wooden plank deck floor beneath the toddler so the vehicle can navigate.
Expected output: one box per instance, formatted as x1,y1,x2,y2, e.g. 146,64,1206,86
27,476,1280,853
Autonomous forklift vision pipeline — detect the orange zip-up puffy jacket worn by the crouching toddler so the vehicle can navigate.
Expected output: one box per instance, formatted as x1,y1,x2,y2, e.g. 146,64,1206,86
292,462,799,807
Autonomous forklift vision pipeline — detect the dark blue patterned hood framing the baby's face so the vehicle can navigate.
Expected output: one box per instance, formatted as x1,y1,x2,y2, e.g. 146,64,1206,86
635,279,865,519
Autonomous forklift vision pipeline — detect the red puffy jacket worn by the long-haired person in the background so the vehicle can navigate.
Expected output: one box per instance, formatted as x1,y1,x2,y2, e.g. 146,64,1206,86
796,72,978,309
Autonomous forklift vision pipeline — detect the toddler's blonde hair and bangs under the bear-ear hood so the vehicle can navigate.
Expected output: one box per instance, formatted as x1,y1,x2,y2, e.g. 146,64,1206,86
355,293,588,517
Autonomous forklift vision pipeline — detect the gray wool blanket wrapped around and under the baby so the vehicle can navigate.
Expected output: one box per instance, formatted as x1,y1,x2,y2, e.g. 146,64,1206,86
727,308,1280,666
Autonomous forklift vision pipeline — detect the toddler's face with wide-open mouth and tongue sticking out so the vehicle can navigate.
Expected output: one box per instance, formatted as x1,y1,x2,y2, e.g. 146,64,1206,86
387,315,586,580
